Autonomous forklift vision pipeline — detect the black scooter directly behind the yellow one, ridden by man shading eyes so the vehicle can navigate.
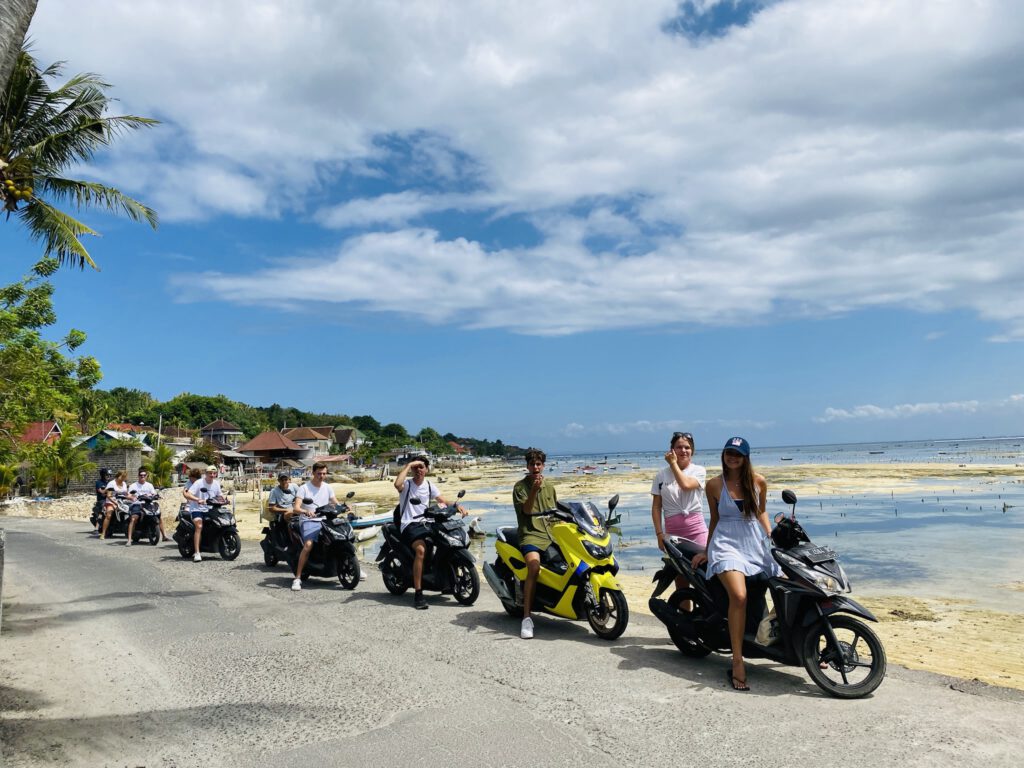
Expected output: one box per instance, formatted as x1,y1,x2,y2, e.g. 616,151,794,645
377,490,480,605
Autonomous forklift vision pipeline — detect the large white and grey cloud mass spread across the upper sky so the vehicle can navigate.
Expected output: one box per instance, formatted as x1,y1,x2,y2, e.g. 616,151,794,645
33,0,1024,335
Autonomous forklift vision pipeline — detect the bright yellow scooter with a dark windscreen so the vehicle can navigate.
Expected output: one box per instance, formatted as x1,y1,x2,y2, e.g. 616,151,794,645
483,496,630,640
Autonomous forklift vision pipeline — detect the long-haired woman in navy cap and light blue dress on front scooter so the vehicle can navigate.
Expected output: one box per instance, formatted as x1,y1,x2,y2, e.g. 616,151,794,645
691,437,780,691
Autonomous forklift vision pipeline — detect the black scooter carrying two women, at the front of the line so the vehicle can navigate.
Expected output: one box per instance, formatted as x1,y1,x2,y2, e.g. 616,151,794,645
648,490,886,698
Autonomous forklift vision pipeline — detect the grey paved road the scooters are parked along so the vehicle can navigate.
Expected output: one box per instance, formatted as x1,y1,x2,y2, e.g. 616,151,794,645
0,518,1024,768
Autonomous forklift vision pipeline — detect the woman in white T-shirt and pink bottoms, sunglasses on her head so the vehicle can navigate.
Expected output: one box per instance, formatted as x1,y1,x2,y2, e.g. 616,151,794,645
650,432,708,608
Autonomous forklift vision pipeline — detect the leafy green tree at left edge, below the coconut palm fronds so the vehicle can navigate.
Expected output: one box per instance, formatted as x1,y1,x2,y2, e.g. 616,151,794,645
0,258,100,443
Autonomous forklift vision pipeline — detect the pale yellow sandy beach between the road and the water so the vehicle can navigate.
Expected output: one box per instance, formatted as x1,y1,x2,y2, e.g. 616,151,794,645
0,463,1024,690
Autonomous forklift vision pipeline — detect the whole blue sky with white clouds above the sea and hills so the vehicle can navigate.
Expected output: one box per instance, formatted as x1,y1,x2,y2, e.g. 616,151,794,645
0,0,1024,452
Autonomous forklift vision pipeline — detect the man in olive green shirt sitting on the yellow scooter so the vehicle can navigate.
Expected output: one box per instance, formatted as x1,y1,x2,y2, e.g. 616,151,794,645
512,447,558,640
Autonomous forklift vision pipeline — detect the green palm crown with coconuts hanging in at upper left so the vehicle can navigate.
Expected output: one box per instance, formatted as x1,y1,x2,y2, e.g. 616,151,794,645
0,49,157,268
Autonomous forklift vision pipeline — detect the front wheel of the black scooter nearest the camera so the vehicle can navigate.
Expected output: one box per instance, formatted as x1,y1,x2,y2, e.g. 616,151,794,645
803,615,886,698
